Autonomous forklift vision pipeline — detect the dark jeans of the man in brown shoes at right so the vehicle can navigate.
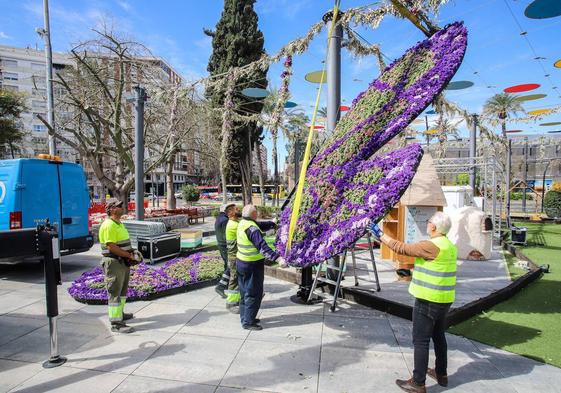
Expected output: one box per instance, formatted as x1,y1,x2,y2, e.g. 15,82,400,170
413,299,452,384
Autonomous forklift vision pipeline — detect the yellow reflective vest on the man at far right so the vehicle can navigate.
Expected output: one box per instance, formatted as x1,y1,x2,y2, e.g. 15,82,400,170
409,236,458,303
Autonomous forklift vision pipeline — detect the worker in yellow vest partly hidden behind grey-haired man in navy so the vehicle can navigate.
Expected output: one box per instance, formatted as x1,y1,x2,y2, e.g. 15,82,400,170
225,203,242,314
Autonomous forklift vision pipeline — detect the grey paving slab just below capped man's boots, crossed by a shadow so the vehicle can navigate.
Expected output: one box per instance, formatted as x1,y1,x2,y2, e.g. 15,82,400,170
68,331,173,374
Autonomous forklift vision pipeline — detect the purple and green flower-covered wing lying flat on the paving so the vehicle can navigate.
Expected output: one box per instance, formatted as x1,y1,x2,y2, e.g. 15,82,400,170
68,252,224,304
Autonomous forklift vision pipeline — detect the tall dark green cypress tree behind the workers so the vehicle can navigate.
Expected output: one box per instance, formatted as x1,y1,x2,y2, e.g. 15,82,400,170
204,0,267,203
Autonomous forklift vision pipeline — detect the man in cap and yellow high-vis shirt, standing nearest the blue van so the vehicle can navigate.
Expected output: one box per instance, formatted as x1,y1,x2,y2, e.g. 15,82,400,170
99,199,136,333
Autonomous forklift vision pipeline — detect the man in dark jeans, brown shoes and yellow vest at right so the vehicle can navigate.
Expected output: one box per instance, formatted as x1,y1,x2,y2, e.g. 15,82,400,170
369,212,458,393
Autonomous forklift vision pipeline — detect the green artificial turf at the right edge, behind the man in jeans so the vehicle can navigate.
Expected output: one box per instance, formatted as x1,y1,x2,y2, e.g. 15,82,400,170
450,223,561,367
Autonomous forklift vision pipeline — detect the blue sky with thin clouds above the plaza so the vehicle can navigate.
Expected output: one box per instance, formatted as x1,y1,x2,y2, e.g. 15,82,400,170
0,0,561,172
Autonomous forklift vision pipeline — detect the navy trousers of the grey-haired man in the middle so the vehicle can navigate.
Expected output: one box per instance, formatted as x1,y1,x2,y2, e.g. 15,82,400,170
236,259,265,326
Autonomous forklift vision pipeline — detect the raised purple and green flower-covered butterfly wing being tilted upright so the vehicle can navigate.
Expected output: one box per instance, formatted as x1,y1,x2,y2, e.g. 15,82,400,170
276,23,467,266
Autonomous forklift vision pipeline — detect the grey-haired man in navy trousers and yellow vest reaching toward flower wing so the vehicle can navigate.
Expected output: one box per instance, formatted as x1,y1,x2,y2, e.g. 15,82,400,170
236,205,286,330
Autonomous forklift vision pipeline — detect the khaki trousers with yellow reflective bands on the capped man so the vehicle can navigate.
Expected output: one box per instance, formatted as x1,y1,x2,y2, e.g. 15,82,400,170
101,257,130,322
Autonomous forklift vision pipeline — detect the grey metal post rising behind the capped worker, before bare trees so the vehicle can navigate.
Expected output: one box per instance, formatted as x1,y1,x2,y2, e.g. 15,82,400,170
134,86,146,221
